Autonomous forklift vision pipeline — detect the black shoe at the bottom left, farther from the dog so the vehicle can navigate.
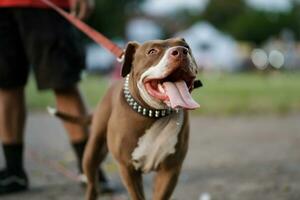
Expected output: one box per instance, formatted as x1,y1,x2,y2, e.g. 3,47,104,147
0,170,29,196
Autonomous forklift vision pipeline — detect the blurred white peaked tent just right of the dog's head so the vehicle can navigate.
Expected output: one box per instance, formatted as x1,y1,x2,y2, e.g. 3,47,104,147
176,22,240,71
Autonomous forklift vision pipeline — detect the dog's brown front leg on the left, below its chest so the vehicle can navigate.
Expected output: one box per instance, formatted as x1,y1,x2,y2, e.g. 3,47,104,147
120,165,145,200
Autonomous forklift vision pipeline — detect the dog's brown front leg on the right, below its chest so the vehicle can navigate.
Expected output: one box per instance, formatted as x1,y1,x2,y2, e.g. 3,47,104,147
153,167,180,200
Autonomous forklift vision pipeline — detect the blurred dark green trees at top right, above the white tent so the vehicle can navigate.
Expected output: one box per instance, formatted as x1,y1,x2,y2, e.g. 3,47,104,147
199,0,300,44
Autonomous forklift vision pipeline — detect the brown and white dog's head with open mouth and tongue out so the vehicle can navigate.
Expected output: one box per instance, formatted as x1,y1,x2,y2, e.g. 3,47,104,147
122,38,199,109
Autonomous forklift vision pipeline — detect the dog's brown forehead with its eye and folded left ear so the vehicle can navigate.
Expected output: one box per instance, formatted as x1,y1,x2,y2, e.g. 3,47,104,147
122,38,189,77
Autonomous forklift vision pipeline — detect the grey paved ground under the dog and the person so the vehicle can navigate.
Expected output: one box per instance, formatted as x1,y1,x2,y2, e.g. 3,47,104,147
0,114,300,200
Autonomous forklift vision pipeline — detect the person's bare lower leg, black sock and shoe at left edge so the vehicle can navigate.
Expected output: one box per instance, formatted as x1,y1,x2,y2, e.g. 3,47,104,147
0,87,28,195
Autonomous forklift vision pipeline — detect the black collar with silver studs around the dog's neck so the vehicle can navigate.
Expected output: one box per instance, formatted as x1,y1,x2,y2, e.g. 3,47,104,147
123,74,173,118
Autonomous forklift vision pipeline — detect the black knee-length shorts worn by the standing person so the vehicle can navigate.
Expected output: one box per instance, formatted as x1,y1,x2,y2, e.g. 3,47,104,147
0,8,85,89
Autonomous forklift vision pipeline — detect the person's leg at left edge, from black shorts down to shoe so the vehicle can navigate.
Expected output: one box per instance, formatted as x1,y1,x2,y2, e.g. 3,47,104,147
0,8,29,195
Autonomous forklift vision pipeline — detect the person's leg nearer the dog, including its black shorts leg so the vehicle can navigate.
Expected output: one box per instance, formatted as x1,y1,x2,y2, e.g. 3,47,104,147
16,8,111,191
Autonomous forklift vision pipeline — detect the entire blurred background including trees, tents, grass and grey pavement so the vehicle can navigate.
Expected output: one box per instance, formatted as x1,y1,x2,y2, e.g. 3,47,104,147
4,0,300,200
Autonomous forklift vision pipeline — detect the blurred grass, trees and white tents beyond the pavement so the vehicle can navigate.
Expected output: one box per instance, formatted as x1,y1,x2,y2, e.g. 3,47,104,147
29,0,300,115
